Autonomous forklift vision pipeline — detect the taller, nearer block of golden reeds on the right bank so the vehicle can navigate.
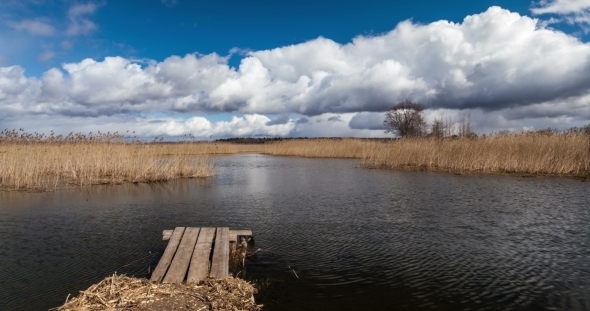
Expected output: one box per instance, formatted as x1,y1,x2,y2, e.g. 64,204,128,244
363,133,590,178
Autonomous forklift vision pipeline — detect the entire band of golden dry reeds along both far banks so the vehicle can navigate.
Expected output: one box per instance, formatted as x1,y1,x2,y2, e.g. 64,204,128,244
0,131,590,190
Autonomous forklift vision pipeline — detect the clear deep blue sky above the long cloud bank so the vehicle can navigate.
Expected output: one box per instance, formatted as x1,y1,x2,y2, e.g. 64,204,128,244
0,0,563,76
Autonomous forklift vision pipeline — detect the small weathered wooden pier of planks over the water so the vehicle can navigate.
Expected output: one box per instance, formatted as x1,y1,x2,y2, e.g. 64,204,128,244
150,227,252,283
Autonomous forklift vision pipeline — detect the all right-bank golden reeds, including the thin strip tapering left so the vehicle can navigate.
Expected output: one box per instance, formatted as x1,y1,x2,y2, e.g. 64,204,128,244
213,132,590,178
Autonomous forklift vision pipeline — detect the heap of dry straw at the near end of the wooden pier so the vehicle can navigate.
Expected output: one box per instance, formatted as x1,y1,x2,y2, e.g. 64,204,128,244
52,275,262,311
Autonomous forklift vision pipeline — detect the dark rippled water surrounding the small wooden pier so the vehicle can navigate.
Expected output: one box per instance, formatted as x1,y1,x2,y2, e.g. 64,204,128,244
0,155,590,310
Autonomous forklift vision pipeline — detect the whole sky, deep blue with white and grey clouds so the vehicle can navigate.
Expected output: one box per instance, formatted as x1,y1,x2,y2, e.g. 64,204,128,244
0,0,590,140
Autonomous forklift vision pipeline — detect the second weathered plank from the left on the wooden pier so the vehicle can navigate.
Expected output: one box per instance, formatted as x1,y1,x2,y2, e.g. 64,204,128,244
162,228,199,283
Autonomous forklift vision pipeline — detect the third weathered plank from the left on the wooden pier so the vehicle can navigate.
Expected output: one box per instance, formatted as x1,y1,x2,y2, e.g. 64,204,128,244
186,228,215,283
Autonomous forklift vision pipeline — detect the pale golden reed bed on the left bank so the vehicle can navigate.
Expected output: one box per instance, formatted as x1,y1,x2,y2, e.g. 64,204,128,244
0,132,213,190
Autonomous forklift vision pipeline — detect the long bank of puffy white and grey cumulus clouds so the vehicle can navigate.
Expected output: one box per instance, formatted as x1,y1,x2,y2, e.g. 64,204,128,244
0,4,590,135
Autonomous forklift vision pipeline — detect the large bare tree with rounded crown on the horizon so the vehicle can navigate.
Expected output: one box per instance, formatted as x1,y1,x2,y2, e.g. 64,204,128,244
383,99,427,137
